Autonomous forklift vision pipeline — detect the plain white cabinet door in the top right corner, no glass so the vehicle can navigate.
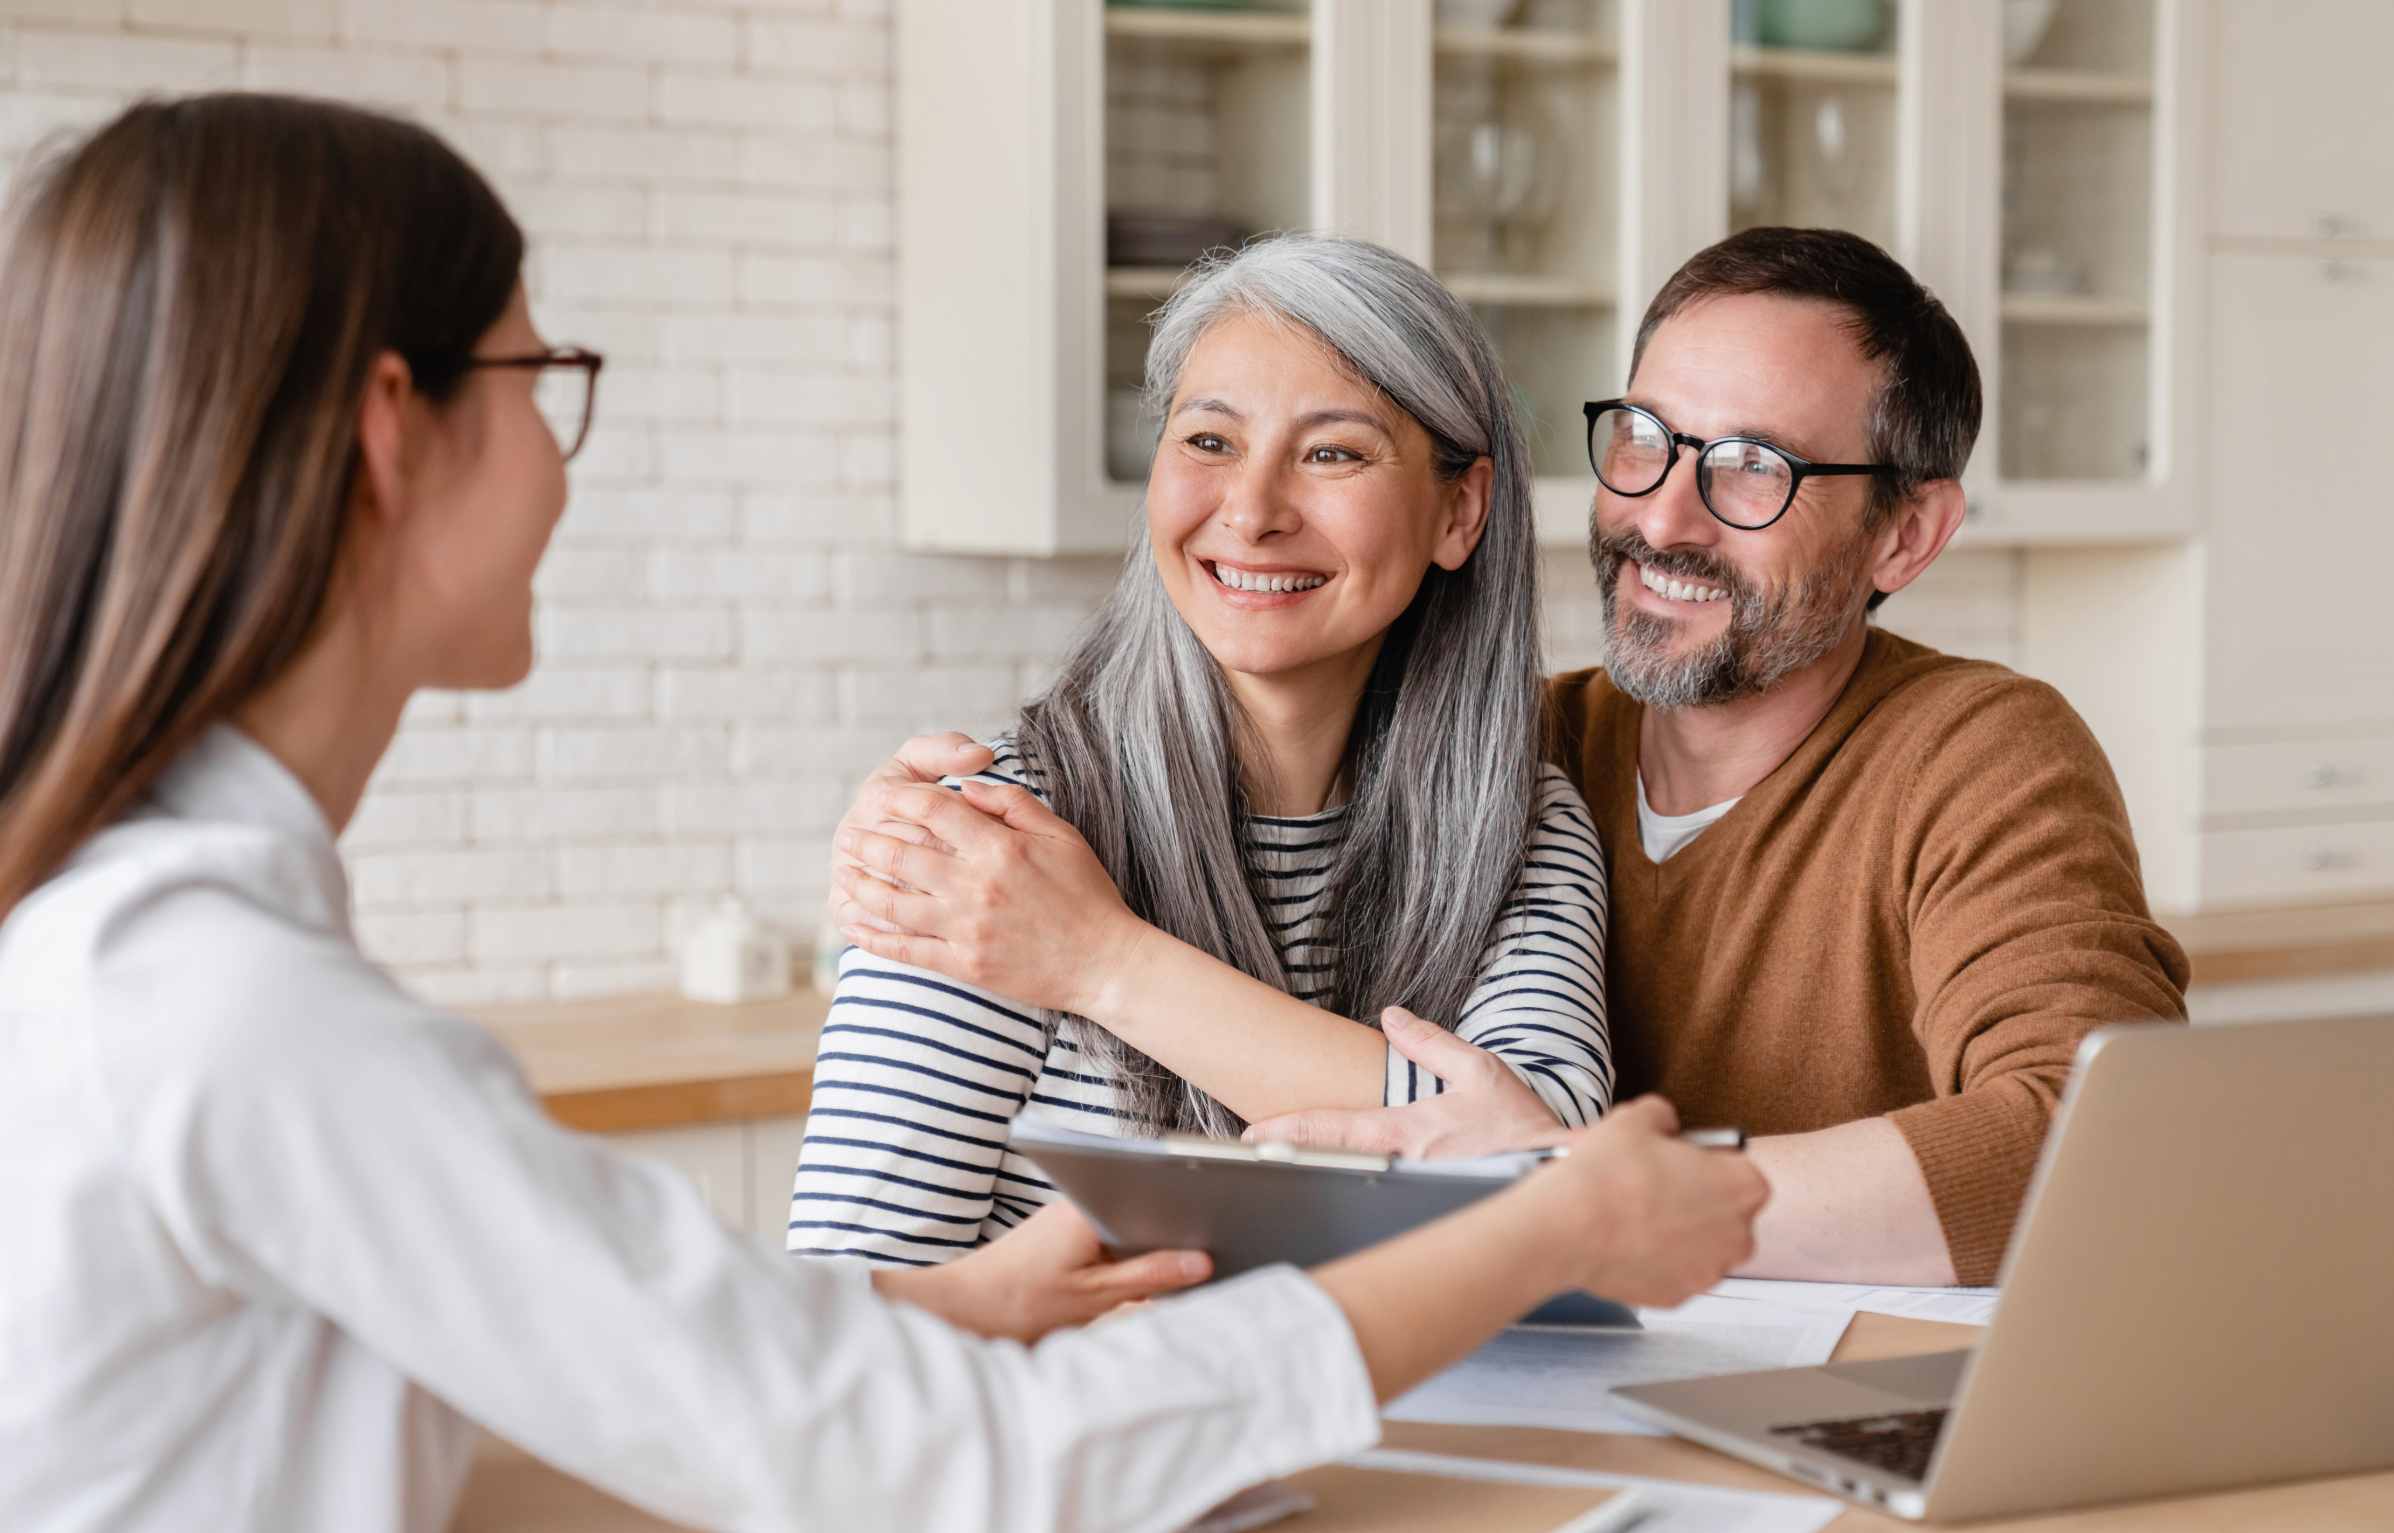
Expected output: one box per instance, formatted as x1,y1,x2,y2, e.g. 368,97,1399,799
2210,0,2394,240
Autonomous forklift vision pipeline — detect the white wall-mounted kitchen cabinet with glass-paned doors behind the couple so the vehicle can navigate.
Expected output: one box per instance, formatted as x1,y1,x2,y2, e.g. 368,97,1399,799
895,0,2207,556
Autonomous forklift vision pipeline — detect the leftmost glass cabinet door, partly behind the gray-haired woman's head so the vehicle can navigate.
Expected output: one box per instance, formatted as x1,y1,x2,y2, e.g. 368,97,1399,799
1101,0,1314,486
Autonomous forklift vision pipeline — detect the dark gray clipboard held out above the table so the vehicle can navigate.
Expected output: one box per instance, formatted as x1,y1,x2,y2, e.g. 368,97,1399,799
1013,1116,1637,1329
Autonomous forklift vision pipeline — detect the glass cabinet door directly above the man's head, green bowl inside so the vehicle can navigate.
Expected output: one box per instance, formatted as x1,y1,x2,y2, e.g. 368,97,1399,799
1726,0,1901,252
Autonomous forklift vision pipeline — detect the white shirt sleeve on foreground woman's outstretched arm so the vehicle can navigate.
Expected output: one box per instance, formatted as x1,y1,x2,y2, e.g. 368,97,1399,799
103,871,1377,1533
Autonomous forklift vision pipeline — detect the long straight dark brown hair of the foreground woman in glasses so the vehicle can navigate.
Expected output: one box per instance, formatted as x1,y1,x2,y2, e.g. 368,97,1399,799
0,93,524,917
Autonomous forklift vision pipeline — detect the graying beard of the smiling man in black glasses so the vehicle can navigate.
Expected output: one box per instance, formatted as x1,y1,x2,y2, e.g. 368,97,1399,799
1592,537,1867,709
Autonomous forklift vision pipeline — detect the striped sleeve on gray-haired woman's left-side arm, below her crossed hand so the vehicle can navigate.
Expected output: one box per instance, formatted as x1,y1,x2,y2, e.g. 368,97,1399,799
788,750,1051,1267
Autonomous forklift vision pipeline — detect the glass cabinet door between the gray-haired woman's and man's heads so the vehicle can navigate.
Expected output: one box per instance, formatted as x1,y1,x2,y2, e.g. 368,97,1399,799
1429,0,1621,491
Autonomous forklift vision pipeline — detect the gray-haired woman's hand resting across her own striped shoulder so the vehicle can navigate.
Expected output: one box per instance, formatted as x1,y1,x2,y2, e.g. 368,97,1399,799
833,783,1159,1020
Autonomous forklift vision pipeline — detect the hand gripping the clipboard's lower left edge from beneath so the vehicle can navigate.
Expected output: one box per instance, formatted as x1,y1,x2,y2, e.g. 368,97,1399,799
874,1202,1214,1341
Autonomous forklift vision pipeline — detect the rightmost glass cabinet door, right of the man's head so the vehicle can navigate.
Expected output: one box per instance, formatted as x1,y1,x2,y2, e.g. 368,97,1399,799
1999,0,2157,481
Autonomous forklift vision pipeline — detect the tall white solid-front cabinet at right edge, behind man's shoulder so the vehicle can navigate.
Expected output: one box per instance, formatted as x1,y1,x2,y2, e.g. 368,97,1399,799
2021,20,2394,910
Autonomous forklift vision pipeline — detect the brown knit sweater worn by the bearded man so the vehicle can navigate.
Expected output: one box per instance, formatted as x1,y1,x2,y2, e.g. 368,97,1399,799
1549,630,2186,1284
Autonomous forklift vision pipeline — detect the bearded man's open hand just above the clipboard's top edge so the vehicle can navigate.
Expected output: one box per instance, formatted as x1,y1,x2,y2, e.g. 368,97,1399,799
1247,1006,1563,1159
